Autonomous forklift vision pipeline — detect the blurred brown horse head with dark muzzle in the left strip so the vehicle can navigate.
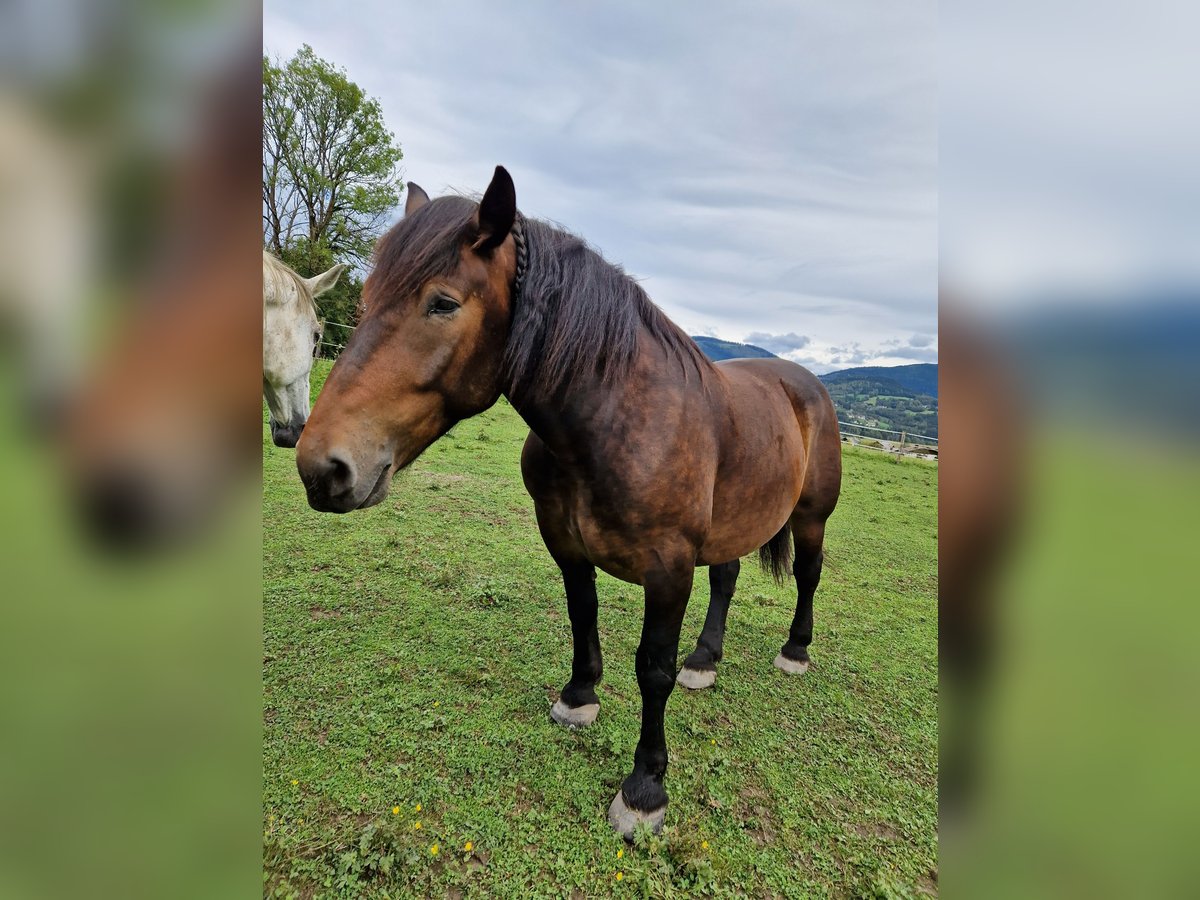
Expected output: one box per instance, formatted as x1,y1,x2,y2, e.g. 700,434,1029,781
59,47,263,549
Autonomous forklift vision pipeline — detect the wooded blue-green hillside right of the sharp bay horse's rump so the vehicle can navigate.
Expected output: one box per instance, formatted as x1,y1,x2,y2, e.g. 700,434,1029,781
821,364,937,439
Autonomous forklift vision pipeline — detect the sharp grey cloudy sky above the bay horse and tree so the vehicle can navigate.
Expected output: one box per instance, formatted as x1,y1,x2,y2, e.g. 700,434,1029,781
263,0,938,372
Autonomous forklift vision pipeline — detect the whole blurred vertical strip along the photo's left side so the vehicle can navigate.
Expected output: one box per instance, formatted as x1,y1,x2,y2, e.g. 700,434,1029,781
0,0,262,898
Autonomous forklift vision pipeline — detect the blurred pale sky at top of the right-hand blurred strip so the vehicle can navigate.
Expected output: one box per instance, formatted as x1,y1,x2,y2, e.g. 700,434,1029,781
938,0,1200,316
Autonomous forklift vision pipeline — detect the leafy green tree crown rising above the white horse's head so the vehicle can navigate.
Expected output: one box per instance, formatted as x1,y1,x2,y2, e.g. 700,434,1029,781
263,44,403,275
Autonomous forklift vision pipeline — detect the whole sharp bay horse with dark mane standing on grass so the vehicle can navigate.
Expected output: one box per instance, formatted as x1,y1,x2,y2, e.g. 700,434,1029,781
296,167,841,838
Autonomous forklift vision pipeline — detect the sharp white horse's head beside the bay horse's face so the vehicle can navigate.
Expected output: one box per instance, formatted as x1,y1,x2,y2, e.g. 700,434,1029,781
263,251,346,446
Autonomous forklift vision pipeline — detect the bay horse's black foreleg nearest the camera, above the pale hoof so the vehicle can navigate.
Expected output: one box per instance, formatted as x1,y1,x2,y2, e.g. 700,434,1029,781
620,566,694,811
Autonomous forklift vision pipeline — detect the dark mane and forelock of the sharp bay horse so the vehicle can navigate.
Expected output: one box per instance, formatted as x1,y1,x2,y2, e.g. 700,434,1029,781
372,197,713,398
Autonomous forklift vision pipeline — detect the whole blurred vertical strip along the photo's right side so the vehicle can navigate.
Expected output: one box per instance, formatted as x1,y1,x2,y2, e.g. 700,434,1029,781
940,2,1200,899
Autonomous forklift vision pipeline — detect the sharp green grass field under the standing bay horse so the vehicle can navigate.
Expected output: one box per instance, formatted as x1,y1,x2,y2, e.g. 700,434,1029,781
263,362,937,898
